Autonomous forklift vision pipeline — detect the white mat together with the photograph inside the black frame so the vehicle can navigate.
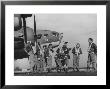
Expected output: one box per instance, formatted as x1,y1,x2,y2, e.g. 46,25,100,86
2,3,106,85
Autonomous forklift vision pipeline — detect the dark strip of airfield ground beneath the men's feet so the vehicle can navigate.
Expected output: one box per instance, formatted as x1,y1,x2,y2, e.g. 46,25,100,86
14,69,97,76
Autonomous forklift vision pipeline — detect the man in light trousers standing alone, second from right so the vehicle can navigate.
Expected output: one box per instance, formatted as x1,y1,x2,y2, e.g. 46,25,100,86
72,43,82,71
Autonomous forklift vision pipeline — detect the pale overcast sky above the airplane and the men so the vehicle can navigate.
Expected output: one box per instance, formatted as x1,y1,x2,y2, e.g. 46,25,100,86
27,14,97,46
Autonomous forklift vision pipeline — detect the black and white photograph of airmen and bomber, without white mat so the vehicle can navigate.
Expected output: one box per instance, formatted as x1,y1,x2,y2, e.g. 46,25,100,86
14,13,97,76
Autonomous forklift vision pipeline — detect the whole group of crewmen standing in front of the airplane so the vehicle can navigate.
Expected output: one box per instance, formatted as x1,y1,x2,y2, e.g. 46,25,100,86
26,38,97,73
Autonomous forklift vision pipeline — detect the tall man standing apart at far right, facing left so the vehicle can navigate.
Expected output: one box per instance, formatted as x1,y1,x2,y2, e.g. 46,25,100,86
87,38,97,71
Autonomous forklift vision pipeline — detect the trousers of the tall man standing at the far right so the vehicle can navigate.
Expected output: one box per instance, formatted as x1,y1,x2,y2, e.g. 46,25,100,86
87,53,97,70
